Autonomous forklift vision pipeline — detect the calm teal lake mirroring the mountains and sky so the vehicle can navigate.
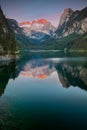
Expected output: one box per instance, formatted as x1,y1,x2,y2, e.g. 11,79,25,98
0,51,87,130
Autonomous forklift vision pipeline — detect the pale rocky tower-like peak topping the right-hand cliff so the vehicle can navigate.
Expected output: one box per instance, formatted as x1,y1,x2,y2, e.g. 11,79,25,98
59,8,73,27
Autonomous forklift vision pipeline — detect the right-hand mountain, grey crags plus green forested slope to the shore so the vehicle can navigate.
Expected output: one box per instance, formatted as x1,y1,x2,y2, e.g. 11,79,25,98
44,7,87,51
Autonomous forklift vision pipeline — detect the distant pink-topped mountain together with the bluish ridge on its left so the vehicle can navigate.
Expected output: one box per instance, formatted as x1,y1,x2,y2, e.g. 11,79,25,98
7,19,56,44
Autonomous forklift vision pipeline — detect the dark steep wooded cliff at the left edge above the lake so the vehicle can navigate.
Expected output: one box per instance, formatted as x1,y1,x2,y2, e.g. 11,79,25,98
0,7,17,51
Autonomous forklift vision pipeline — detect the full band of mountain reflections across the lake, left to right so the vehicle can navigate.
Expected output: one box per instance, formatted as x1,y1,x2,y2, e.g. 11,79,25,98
0,52,87,96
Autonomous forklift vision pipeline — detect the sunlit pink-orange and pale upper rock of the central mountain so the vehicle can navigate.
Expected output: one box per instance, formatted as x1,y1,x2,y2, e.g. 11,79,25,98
19,19,55,37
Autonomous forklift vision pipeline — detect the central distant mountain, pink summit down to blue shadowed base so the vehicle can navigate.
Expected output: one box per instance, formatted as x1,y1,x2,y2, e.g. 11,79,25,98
23,19,56,42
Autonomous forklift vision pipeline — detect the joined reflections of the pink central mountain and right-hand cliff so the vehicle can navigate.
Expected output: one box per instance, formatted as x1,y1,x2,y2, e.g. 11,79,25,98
19,54,87,90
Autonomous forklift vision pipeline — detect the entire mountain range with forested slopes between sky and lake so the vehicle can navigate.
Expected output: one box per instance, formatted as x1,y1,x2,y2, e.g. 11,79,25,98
0,7,87,50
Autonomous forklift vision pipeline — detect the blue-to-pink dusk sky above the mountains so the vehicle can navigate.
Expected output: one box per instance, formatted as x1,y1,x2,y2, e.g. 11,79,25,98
0,0,87,26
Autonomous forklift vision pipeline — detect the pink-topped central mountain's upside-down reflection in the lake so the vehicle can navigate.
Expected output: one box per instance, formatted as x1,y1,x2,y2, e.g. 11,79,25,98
20,59,55,79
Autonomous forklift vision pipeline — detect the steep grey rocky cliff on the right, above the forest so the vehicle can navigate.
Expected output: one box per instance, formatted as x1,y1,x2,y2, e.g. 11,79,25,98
57,7,87,38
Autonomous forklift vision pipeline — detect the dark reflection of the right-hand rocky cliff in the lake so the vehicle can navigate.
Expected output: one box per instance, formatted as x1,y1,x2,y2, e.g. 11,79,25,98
56,62,87,90
